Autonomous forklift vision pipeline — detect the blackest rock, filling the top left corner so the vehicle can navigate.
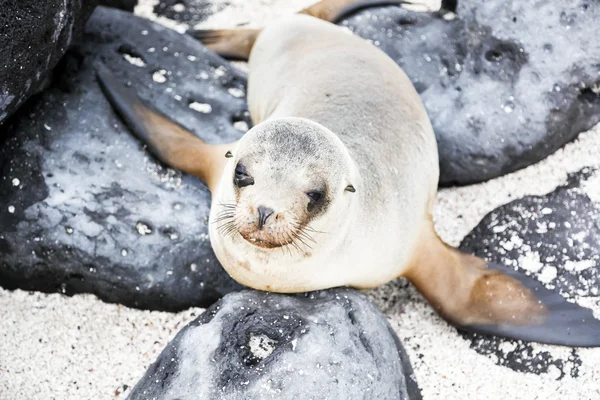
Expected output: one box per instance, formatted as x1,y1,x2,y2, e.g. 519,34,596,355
0,0,95,127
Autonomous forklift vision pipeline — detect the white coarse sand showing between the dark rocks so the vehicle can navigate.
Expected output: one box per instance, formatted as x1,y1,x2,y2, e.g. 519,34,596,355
0,0,600,400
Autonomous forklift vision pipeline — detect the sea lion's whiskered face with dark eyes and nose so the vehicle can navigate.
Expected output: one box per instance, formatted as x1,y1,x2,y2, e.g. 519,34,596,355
214,119,354,254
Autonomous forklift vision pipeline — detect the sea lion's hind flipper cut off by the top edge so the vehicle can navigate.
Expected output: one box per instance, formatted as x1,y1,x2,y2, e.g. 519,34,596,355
299,0,412,24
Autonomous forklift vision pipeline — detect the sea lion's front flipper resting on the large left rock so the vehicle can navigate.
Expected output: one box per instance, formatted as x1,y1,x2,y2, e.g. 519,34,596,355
96,64,236,191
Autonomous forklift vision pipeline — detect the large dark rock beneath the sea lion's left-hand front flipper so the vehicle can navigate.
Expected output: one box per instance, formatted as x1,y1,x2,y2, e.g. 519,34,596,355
0,7,250,310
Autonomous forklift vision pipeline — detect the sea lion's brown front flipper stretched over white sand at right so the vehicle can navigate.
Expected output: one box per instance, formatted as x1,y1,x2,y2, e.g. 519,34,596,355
406,231,600,347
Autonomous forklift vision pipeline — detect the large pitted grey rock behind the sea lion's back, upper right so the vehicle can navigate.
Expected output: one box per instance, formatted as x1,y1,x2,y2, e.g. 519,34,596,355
341,0,600,185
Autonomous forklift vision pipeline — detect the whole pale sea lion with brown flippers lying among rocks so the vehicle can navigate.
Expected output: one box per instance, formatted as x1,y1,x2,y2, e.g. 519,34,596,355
98,1,600,346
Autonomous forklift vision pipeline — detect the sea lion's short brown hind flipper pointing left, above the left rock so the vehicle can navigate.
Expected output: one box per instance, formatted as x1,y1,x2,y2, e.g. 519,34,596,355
188,29,260,61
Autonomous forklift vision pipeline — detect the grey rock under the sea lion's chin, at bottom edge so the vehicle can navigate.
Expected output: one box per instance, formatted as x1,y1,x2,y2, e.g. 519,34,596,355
128,289,421,400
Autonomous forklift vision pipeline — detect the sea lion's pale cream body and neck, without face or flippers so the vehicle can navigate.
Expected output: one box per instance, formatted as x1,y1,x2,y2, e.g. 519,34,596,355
210,15,439,292
